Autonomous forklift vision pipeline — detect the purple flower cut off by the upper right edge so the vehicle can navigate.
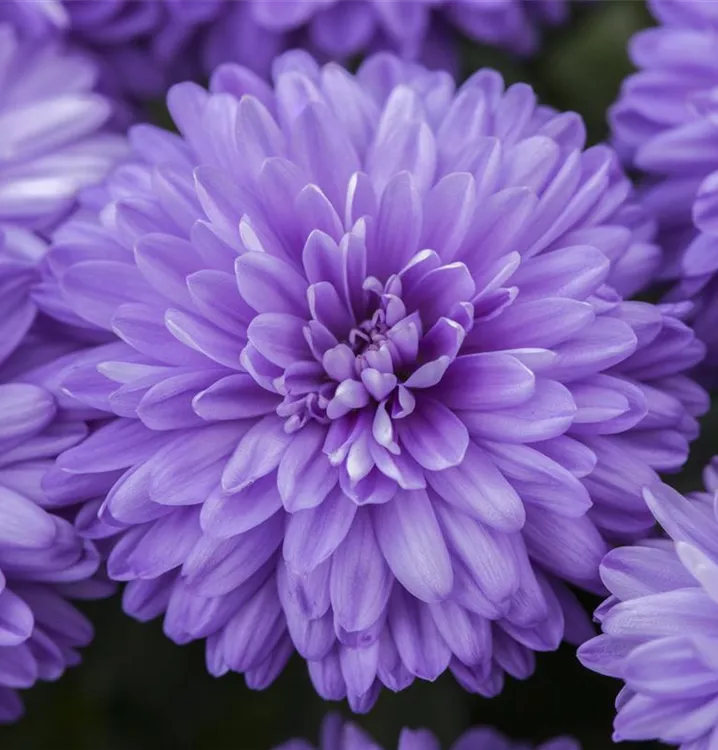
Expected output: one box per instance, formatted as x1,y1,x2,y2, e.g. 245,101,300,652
610,0,718,373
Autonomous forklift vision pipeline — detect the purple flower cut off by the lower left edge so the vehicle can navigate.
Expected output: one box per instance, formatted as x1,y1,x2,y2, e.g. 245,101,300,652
0,374,102,723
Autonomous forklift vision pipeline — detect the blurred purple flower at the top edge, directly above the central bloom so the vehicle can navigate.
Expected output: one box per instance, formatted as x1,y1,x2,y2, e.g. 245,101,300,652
204,0,570,71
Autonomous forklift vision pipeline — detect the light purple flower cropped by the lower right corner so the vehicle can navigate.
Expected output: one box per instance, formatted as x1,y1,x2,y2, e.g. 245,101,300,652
578,468,718,750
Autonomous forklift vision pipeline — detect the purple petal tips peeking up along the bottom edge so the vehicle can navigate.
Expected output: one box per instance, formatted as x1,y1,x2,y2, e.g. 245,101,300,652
276,715,581,750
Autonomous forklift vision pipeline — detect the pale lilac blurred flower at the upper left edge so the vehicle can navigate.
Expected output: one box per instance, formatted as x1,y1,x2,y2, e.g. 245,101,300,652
0,24,125,232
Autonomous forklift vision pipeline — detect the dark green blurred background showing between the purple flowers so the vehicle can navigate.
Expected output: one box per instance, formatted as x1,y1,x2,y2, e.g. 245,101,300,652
0,0,680,750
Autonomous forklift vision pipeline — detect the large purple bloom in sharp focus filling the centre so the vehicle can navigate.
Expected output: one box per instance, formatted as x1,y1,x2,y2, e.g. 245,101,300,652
46,52,707,711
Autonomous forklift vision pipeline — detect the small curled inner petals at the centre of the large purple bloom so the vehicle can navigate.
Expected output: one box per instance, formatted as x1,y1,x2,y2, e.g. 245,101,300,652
240,247,475,478
